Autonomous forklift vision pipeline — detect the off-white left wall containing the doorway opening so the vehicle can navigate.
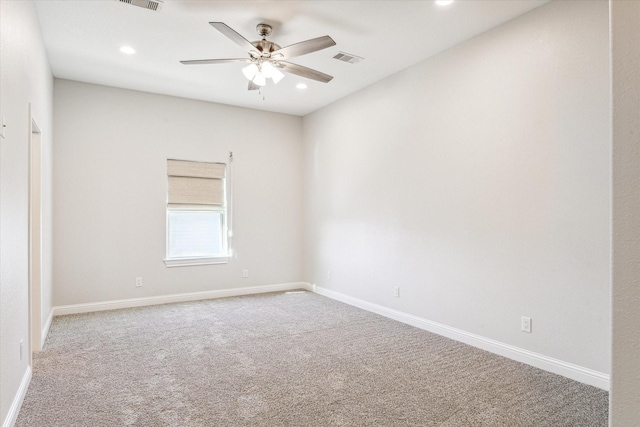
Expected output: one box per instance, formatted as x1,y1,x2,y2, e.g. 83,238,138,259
0,0,53,425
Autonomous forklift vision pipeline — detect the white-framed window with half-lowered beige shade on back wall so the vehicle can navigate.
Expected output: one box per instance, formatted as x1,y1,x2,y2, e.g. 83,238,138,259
165,160,230,267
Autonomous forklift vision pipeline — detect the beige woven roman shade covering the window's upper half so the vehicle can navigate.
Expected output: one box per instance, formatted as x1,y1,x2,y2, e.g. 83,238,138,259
167,160,226,206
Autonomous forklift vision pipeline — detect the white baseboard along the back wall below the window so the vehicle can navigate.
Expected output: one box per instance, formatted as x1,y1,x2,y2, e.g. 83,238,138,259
52,282,305,316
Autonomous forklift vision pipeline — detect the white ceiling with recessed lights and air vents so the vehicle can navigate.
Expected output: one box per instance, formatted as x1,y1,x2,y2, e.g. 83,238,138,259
36,0,549,116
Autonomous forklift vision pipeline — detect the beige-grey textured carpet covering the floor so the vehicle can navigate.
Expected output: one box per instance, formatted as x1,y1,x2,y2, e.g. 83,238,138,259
16,292,608,427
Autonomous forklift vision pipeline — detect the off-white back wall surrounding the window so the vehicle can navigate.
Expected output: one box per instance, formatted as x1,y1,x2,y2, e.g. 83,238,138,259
54,79,302,306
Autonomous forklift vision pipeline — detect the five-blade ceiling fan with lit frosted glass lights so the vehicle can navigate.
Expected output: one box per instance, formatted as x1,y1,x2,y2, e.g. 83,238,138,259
180,22,336,90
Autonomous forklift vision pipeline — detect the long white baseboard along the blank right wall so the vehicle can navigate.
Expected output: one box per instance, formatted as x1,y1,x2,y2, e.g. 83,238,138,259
303,283,609,390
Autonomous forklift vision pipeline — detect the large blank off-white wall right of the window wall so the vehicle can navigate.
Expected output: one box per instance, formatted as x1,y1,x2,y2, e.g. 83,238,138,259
304,1,610,374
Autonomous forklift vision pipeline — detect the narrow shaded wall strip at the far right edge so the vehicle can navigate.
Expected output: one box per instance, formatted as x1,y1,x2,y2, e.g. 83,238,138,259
609,0,640,427
